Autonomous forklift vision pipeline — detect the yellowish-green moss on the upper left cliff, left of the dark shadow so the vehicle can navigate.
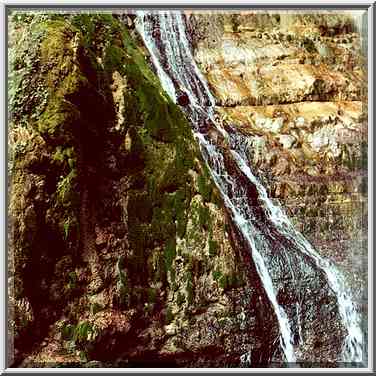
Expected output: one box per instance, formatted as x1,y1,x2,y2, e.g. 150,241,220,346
9,20,85,264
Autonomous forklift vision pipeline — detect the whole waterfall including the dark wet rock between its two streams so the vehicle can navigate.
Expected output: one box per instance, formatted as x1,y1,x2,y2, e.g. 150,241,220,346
137,11,364,363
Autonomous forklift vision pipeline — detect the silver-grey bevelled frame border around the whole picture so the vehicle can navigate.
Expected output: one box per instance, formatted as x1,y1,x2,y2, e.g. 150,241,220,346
0,0,376,374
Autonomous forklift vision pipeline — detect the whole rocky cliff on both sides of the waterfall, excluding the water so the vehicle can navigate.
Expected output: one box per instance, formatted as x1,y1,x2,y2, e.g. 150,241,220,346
8,12,367,367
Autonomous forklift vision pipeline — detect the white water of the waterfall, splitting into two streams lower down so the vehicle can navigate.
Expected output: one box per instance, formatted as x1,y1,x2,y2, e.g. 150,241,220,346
137,11,364,363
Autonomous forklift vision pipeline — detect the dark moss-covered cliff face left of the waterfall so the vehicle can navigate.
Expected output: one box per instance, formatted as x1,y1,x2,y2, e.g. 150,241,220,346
8,13,278,367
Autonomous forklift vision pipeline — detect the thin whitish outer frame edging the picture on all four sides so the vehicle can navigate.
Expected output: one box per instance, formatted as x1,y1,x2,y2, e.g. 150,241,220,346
0,0,375,374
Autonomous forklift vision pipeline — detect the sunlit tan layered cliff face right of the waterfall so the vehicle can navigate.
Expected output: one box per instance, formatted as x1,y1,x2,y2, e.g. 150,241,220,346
187,11,367,313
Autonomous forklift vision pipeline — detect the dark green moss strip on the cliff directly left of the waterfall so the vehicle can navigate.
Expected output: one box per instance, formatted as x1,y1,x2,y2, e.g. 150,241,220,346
86,17,211,298
